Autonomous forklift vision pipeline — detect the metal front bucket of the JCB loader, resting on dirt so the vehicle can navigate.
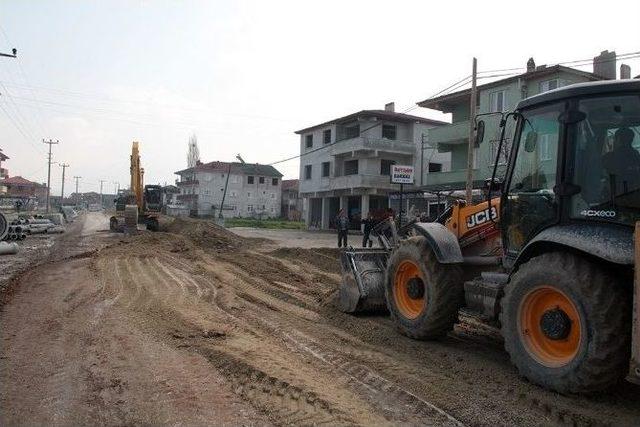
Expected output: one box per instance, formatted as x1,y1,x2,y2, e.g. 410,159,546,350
337,249,389,313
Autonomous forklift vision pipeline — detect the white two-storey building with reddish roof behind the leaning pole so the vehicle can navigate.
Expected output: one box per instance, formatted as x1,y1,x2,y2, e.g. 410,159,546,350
175,162,282,218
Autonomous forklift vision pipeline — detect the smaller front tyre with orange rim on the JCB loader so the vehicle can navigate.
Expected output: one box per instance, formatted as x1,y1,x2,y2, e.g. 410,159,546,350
385,237,464,340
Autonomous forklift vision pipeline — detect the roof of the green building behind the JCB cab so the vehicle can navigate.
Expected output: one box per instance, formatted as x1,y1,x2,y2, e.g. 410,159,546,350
417,65,603,110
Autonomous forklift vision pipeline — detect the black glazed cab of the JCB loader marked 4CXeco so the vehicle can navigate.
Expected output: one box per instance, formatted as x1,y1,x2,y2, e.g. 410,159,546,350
480,80,640,268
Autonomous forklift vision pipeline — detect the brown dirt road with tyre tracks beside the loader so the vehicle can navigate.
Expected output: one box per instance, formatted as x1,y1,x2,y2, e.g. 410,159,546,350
0,214,640,425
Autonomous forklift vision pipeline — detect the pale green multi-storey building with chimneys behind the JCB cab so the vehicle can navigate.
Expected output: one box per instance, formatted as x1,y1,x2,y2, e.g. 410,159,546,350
418,51,616,190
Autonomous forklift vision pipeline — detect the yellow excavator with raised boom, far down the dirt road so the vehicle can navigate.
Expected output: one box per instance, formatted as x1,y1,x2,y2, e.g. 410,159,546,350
109,141,162,231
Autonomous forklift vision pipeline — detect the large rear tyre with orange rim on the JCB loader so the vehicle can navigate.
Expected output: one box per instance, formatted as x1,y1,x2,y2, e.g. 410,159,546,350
500,252,631,393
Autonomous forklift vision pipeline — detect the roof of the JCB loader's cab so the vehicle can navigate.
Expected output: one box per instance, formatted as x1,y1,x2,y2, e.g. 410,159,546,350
516,79,640,109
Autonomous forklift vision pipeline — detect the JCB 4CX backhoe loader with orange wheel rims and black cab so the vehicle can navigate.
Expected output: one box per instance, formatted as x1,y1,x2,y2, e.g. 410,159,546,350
339,80,640,392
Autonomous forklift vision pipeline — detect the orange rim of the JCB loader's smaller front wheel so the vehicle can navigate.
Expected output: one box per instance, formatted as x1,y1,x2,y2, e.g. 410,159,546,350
393,260,426,319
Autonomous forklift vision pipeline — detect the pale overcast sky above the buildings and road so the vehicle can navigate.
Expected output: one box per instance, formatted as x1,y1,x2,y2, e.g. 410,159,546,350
0,0,640,195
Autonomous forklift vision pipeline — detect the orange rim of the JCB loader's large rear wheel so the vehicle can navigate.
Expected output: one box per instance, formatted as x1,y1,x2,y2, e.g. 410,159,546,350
518,286,582,368
